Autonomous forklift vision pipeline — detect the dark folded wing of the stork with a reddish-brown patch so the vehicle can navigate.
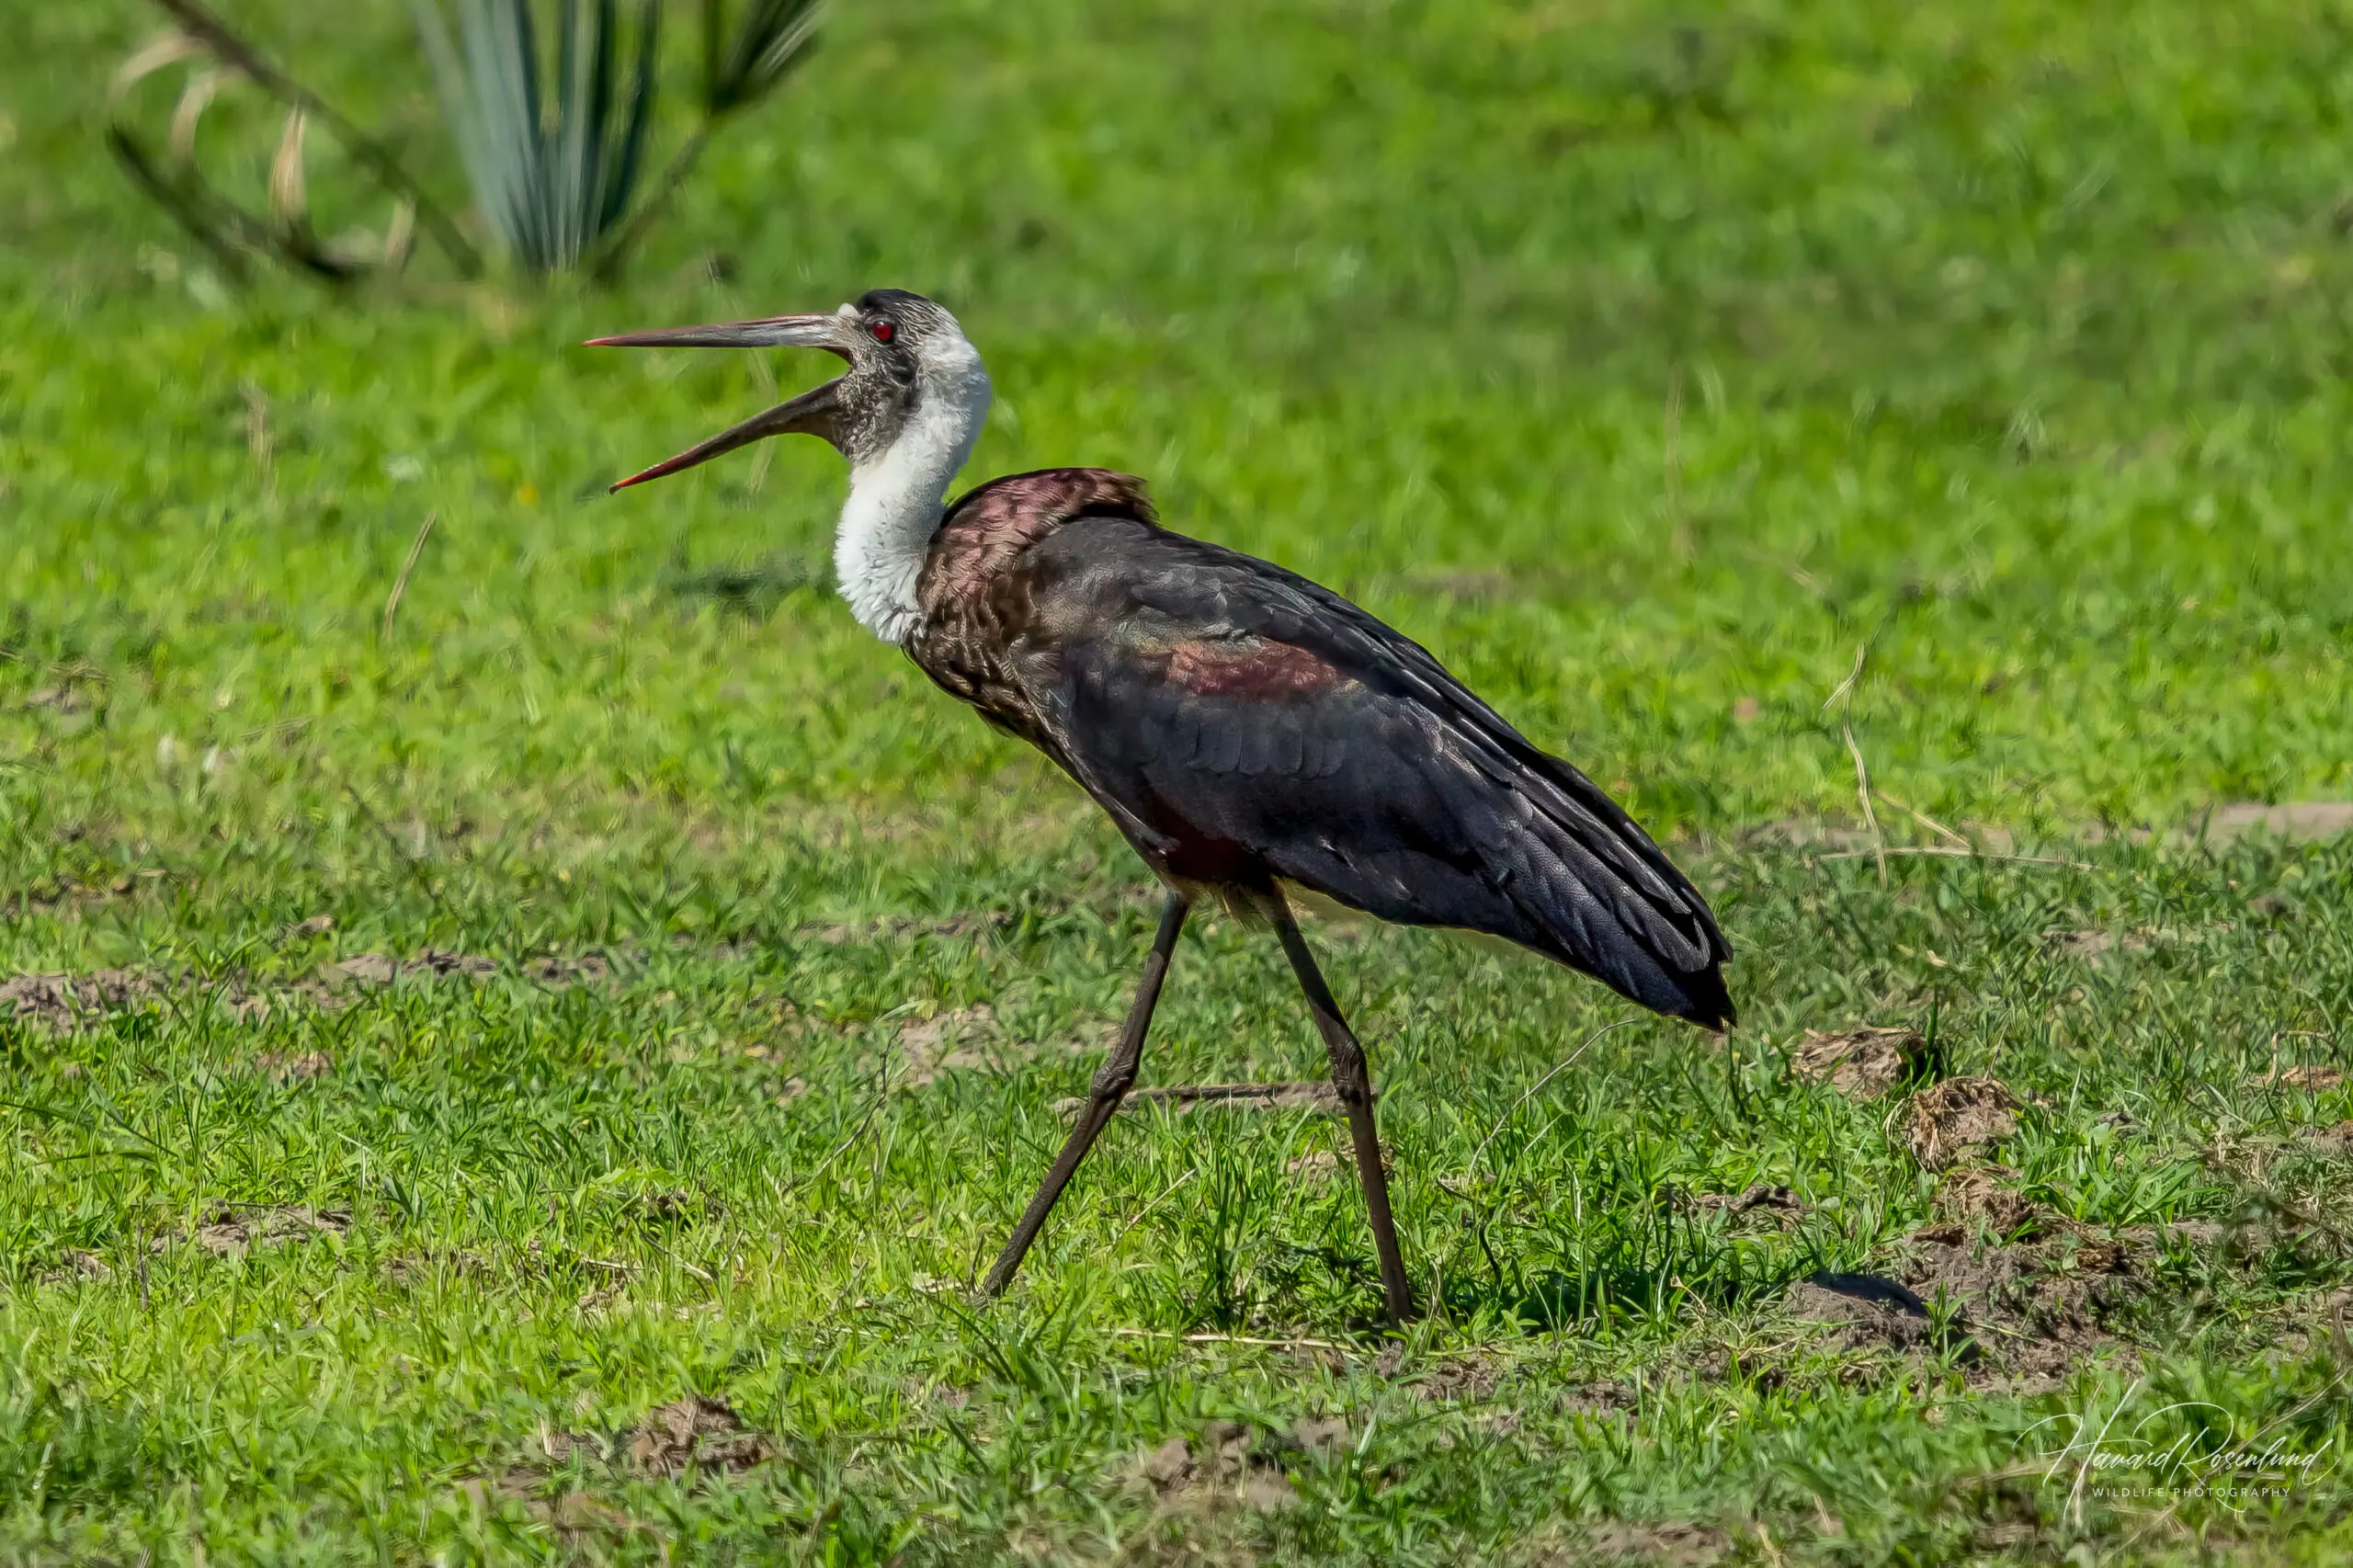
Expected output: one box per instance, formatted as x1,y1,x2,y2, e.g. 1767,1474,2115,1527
1021,518,1732,1024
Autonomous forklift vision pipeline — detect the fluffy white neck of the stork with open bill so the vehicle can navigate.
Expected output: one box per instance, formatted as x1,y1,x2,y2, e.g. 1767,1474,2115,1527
833,332,991,645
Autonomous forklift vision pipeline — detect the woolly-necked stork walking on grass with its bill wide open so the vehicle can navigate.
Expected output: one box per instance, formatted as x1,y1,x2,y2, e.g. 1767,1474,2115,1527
596,290,1732,1318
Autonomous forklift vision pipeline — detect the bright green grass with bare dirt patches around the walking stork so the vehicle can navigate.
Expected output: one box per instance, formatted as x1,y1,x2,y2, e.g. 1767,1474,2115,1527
0,0,2353,1563
